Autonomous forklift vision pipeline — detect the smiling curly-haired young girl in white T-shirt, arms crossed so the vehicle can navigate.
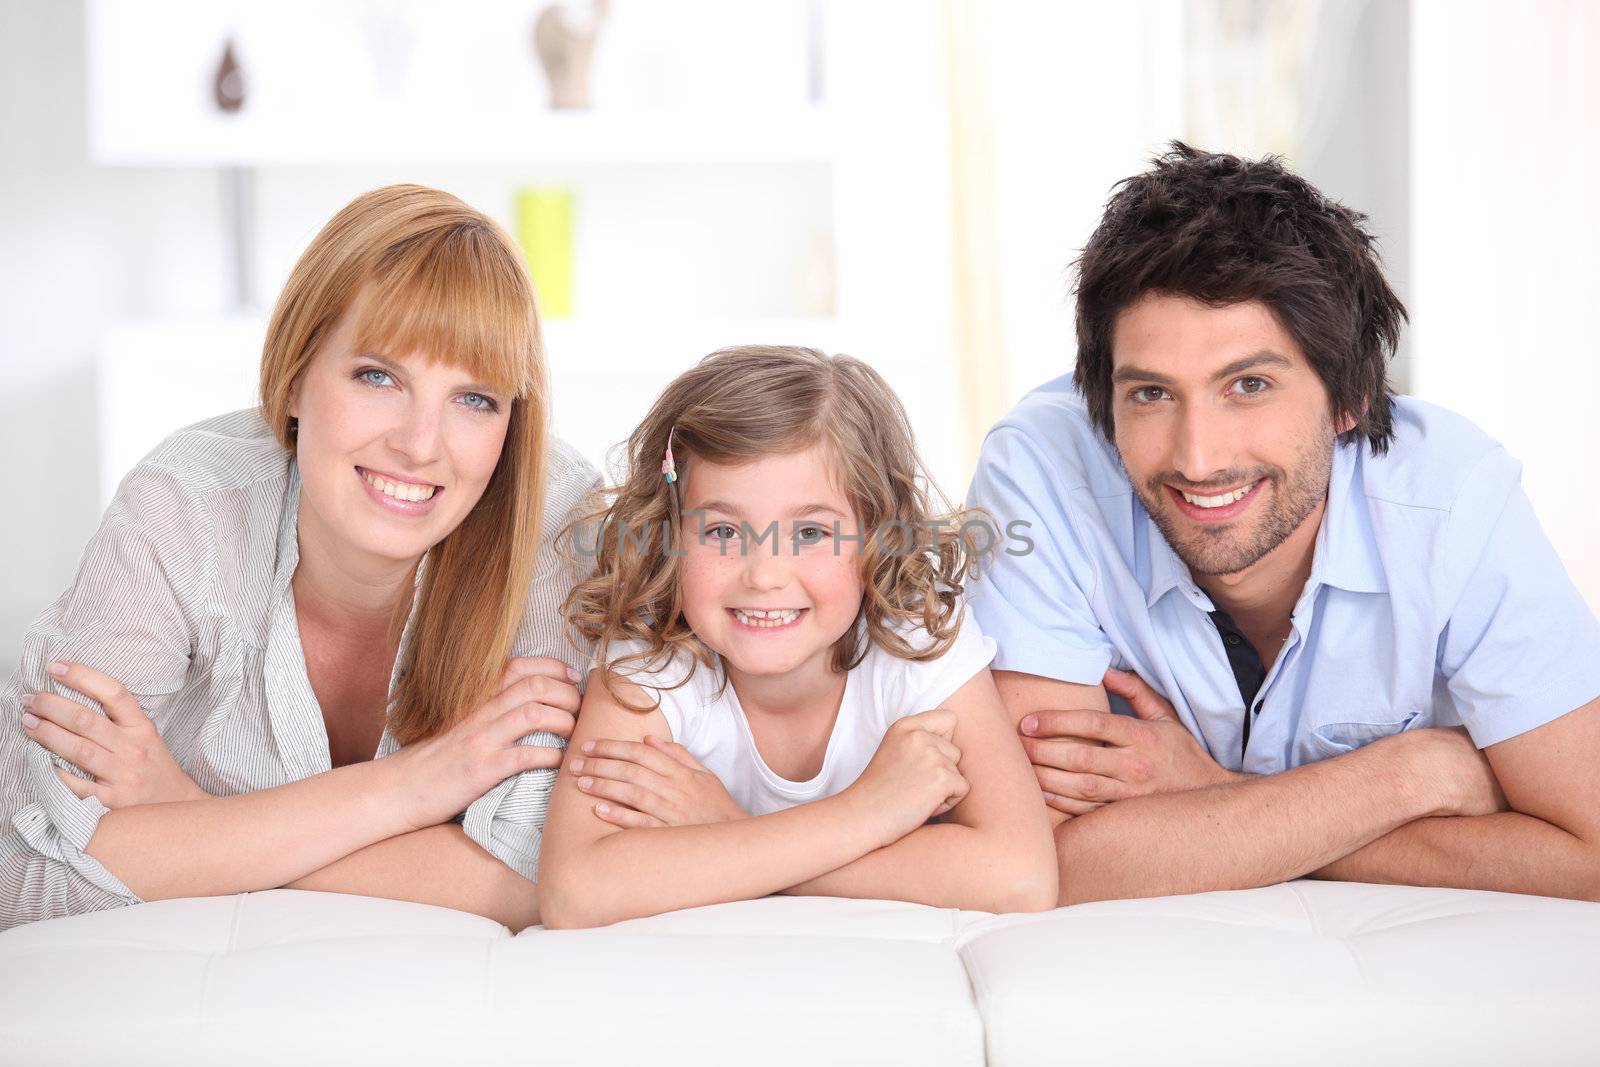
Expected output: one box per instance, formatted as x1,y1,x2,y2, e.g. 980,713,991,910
541,347,1056,926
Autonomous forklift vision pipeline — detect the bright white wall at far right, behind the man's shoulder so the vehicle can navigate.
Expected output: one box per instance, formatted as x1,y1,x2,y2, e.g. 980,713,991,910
1411,0,1600,611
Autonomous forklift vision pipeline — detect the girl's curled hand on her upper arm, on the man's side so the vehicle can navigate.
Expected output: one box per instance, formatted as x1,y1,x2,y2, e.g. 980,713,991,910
850,707,970,845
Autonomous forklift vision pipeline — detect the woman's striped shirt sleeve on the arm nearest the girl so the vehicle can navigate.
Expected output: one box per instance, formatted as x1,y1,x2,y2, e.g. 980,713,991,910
461,445,600,881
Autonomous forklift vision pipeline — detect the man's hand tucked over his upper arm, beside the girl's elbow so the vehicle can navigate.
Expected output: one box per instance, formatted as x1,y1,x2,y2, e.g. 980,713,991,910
1021,670,1243,816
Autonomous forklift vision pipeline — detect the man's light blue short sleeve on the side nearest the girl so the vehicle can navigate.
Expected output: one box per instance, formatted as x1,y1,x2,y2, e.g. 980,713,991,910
966,427,1112,685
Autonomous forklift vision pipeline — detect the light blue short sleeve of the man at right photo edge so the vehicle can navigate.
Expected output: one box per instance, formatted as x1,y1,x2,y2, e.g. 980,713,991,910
1438,450,1600,749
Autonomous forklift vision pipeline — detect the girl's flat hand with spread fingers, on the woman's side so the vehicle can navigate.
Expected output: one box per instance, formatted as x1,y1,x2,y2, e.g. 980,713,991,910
566,736,746,829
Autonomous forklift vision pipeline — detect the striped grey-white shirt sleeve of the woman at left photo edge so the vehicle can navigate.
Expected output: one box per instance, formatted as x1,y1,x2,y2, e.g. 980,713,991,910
0,467,203,928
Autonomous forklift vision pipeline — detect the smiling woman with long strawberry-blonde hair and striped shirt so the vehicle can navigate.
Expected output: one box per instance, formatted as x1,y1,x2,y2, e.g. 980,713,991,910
0,186,595,928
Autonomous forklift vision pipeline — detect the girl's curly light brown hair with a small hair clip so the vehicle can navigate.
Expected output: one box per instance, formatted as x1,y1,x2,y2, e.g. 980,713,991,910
565,346,992,701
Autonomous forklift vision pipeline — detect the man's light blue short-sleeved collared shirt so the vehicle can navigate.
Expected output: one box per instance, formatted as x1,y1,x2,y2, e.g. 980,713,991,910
966,376,1600,774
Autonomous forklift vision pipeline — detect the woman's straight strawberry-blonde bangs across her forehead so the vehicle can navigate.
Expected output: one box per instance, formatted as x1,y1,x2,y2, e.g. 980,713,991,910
355,232,539,397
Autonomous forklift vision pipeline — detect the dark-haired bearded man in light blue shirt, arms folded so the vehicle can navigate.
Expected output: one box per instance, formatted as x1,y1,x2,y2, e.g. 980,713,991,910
968,144,1600,904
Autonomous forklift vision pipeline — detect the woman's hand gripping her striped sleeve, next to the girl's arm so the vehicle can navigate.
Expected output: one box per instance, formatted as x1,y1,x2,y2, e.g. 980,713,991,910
382,657,579,830
